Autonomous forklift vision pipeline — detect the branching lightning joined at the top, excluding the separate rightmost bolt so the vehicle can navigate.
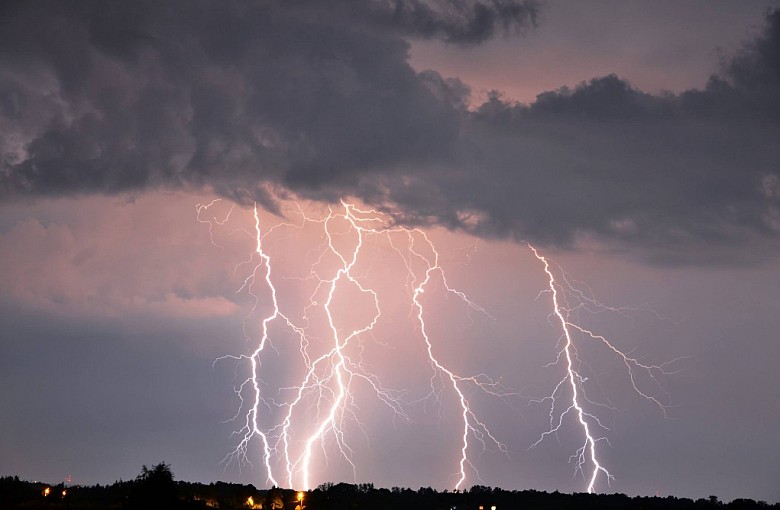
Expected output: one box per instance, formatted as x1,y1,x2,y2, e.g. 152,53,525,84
212,202,509,490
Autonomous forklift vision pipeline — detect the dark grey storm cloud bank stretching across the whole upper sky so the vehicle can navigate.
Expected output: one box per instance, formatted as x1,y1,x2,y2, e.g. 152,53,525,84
0,0,780,263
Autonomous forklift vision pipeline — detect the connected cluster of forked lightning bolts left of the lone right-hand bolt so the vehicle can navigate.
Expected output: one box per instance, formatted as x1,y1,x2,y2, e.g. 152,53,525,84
216,202,508,490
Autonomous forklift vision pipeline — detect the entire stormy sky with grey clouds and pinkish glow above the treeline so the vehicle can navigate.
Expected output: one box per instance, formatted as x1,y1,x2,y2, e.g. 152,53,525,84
0,0,780,502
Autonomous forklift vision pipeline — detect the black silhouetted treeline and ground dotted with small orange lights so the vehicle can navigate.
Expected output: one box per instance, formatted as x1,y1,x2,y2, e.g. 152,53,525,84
0,464,780,510
